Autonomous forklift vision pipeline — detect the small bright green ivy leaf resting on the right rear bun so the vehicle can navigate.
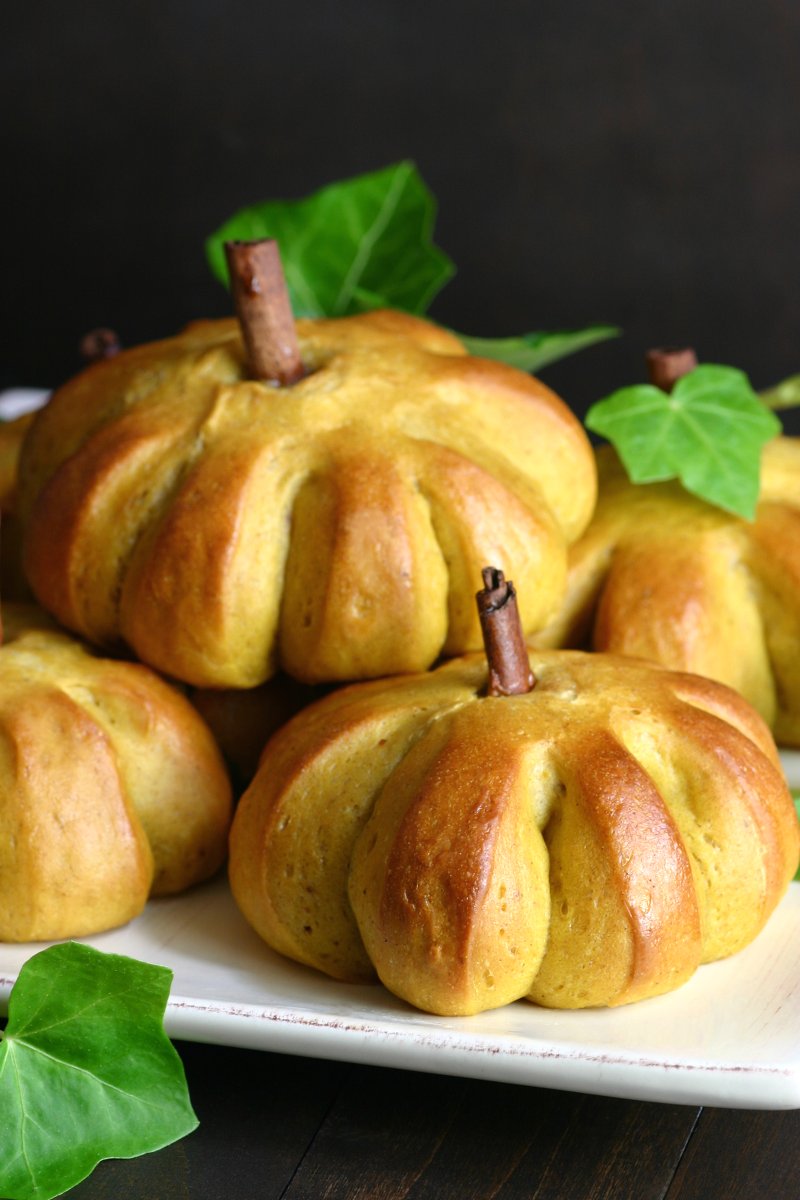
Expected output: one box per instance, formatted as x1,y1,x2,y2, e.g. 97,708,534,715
587,365,781,520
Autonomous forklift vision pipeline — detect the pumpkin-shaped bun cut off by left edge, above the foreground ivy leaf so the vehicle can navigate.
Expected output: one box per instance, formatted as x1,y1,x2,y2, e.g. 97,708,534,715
0,606,231,942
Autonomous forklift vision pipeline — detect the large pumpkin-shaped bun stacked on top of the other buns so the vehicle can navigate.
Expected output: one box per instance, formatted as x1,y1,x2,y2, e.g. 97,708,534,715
20,312,596,688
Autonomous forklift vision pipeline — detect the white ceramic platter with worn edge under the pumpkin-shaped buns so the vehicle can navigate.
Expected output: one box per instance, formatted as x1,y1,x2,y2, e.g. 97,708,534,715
0,752,800,1109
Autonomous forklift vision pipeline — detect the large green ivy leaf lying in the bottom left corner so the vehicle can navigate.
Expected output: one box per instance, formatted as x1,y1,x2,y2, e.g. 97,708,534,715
0,942,198,1200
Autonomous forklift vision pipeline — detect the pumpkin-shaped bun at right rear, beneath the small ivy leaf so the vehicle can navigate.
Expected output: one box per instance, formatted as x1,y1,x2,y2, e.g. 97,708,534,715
533,438,800,745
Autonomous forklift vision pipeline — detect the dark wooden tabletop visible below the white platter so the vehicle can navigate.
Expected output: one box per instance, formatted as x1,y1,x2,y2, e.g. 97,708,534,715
70,1043,800,1200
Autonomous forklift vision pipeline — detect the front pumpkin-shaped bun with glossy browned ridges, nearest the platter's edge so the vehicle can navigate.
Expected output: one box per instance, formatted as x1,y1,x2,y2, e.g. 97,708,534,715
229,650,800,1014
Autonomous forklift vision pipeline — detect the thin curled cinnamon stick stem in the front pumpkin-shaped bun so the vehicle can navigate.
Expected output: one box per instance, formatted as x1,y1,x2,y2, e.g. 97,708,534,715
475,566,536,696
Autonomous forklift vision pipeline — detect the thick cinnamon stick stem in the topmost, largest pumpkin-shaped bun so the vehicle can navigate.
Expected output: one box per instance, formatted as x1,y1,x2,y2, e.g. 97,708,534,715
225,238,305,385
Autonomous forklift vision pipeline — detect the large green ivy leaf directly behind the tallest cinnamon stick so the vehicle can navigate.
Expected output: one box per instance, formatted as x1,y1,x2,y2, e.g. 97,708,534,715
206,162,455,317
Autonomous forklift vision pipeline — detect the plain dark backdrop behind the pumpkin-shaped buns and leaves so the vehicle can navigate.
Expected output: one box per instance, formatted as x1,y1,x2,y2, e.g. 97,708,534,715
0,0,800,427
